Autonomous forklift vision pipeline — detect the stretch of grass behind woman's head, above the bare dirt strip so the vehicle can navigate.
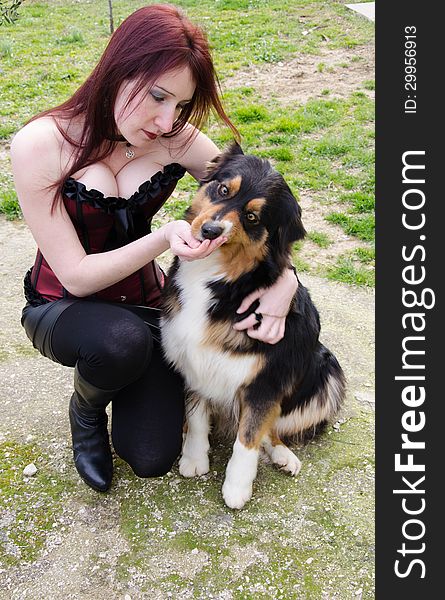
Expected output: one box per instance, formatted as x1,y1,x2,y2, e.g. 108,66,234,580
0,0,373,132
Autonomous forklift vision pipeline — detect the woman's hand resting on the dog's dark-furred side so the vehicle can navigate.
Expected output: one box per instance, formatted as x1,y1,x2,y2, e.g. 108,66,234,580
233,269,298,344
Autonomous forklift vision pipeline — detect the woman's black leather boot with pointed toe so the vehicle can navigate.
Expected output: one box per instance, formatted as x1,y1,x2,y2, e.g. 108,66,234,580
69,365,118,492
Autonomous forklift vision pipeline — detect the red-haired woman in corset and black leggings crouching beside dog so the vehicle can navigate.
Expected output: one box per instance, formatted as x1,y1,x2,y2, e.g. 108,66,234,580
11,5,297,491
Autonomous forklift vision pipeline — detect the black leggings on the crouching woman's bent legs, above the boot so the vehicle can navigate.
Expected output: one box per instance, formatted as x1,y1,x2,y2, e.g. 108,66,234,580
22,299,184,477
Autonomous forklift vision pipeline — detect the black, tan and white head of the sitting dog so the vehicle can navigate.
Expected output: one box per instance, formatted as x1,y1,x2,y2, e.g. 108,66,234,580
186,143,305,278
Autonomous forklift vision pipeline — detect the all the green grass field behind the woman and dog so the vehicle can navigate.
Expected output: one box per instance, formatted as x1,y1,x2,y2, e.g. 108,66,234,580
0,0,375,288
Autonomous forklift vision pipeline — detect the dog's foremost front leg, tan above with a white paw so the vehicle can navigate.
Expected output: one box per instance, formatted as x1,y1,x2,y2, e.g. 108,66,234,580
222,403,280,508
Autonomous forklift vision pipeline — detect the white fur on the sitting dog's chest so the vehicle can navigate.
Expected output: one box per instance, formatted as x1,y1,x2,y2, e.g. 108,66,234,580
162,251,258,408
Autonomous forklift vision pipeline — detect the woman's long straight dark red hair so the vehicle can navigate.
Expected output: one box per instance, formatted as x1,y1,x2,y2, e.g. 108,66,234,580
31,4,239,208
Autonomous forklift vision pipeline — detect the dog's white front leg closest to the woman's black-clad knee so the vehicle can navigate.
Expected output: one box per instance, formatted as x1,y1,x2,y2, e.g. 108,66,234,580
179,395,210,477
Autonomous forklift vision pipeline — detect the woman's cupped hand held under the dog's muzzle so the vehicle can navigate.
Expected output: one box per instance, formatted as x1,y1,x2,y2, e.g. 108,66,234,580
163,221,227,260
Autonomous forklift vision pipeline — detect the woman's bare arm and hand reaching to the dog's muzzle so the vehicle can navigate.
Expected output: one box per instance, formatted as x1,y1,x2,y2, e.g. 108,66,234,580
11,119,223,297
